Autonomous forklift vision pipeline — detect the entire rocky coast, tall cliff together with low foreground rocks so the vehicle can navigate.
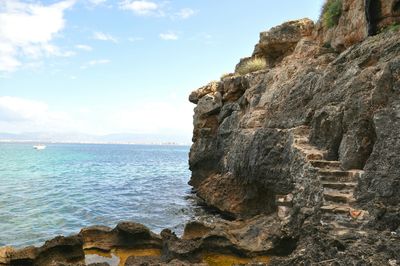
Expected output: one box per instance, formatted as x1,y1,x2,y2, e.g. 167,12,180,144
0,0,400,266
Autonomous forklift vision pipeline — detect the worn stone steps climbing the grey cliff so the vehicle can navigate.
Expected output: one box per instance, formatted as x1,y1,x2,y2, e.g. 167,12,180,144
277,126,368,236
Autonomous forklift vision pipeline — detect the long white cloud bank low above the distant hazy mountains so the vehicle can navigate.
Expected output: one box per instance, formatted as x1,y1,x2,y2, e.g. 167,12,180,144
0,96,193,139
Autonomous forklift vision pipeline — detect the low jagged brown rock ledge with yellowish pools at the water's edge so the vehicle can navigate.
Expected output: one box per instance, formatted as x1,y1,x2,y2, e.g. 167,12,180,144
0,219,286,266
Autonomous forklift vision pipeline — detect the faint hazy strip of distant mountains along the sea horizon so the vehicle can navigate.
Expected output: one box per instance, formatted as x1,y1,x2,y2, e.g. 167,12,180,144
0,132,191,144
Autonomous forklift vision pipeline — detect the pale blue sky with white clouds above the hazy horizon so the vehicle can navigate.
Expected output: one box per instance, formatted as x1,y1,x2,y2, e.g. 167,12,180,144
0,0,323,141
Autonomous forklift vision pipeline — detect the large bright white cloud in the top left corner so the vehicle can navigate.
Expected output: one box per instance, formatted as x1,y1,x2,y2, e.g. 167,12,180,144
0,0,75,72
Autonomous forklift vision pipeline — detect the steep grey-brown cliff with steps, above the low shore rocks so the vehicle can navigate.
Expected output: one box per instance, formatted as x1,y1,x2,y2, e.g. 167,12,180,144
189,0,400,234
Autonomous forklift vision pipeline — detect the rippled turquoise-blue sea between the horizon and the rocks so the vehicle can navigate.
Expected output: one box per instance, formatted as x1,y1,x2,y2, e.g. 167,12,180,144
0,143,193,247
